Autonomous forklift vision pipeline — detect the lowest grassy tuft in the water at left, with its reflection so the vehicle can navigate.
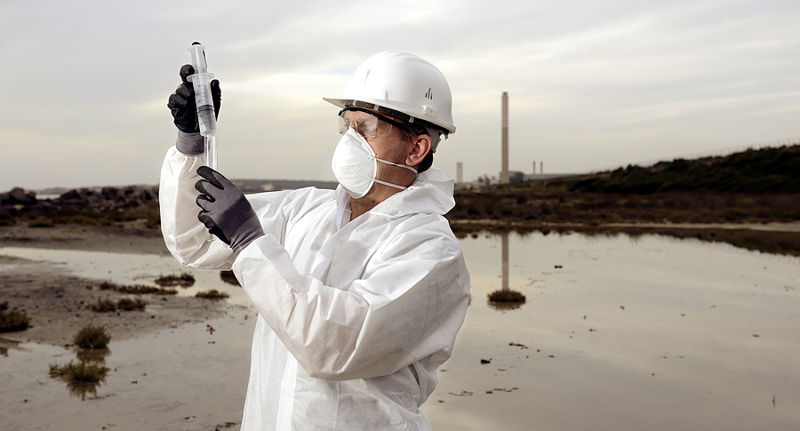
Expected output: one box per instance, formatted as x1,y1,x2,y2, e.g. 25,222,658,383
50,348,111,401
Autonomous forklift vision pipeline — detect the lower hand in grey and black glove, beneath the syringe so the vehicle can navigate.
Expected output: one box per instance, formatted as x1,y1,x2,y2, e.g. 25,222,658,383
194,166,264,253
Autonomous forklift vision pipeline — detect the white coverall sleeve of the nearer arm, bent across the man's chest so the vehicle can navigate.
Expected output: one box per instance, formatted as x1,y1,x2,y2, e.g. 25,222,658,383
233,223,469,380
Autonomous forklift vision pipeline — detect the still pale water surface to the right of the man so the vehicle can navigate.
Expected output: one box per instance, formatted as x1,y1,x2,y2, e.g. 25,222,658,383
422,233,800,431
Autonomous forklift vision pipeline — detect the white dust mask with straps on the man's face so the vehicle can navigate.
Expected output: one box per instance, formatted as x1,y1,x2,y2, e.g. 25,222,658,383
331,127,417,199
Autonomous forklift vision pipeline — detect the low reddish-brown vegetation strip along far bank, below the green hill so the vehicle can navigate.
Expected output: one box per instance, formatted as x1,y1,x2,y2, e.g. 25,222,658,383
454,191,800,228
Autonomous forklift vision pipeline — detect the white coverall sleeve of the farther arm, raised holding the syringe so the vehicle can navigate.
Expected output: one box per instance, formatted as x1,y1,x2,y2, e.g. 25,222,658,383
158,146,291,270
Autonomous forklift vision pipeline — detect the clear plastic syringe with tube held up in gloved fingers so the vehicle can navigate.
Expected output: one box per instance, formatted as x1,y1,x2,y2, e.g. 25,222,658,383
187,42,217,170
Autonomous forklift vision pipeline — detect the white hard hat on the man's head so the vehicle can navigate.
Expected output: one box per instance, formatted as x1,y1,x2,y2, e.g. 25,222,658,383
323,51,456,134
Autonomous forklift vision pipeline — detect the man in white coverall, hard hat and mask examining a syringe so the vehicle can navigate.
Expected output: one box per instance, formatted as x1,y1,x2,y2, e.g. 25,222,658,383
160,51,469,431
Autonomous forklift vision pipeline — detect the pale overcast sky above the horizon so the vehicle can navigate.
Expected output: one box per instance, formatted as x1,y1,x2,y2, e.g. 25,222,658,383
0,0,800,190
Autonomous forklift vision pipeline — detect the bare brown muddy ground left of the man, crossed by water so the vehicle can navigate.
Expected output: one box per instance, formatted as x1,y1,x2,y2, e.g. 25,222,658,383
0,226,232,345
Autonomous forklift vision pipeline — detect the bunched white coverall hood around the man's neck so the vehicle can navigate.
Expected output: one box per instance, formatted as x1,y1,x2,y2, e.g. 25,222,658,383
336,168,456,217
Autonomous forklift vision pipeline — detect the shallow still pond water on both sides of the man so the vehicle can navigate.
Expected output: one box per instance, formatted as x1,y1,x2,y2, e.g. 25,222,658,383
0,233,800,430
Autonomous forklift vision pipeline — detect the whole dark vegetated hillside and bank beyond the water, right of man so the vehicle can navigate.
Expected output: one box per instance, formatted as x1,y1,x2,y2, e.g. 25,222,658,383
448,145,800,228
